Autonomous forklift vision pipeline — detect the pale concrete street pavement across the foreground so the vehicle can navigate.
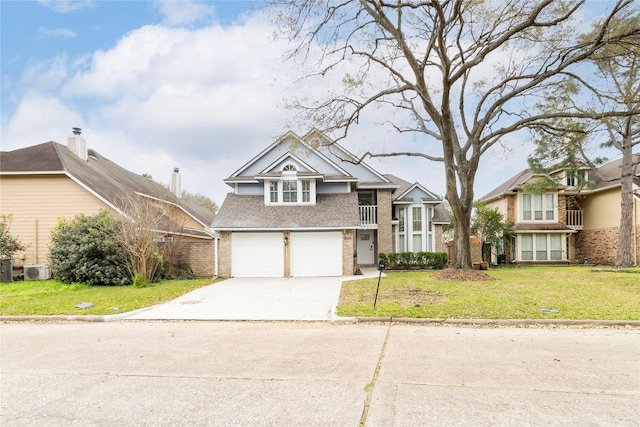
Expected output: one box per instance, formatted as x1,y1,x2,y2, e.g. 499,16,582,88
0,320,640,427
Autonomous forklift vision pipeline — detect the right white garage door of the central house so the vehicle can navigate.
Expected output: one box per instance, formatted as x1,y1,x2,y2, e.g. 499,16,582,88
289,231,342,277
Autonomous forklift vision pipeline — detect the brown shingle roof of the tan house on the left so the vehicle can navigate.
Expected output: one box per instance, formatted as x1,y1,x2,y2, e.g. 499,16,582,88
0,141,215,235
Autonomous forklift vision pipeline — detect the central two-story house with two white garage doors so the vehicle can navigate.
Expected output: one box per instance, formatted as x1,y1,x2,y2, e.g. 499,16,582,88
212,131,449,277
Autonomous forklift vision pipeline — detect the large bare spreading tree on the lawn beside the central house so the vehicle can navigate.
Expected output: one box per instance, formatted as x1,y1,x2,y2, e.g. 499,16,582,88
271,0,638,268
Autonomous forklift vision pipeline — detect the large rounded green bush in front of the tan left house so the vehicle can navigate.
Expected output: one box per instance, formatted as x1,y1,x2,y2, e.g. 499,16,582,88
49,211,131,286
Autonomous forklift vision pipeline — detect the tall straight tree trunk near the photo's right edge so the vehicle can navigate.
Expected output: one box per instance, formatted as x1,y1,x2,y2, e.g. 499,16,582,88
615,123,633,267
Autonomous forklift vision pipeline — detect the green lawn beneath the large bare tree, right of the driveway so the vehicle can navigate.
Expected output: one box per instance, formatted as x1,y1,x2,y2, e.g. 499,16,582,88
337,266,640,320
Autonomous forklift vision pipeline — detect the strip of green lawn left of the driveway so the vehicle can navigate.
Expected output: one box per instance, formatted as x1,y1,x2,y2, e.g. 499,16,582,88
0,279,216,316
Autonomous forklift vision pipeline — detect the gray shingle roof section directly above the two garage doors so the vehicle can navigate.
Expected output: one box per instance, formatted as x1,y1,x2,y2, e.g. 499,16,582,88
211,192,360,230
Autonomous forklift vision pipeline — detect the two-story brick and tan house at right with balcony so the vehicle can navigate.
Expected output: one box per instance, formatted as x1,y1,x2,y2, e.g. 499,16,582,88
480,155,640,265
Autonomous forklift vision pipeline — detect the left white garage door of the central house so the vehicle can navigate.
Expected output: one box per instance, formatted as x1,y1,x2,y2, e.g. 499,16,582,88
231,233,284,277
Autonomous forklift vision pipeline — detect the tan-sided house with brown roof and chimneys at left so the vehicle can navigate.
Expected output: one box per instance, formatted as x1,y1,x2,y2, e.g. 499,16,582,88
0,128,215,276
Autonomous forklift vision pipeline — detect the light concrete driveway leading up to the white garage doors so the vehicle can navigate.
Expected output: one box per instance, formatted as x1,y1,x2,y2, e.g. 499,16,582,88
119,276,350,320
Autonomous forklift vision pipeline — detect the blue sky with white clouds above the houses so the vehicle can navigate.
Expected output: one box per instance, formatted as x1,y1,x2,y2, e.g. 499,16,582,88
0,0,620,205
